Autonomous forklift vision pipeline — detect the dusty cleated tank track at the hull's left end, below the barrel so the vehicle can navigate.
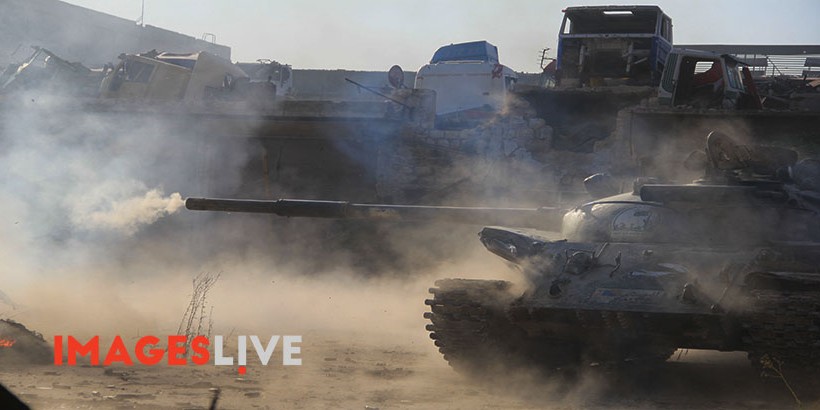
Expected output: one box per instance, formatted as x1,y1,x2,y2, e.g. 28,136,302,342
424,279,577,377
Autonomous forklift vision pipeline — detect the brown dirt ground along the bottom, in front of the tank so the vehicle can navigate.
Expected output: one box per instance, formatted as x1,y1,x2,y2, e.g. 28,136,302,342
0,331,820,410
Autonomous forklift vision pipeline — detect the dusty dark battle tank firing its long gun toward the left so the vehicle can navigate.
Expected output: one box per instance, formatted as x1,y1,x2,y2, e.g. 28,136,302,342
186,133,820,373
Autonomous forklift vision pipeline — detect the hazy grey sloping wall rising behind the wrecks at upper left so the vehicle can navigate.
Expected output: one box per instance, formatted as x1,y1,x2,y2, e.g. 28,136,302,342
0,0,231,67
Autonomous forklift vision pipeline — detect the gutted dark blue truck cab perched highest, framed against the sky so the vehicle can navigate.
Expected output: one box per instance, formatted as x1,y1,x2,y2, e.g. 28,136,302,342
555,6,672,88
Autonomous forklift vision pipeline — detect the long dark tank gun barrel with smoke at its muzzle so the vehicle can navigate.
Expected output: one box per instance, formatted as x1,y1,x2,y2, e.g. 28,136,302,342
185,198,564,228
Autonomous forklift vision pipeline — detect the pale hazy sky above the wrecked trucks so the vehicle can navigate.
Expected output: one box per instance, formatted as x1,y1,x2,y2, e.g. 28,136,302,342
60,0,820,72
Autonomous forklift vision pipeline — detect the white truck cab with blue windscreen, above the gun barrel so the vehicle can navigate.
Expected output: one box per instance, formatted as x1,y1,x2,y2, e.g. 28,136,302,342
414,41,518,123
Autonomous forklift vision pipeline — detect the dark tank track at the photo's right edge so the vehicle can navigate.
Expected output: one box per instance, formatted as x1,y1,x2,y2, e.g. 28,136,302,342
743,290,820,375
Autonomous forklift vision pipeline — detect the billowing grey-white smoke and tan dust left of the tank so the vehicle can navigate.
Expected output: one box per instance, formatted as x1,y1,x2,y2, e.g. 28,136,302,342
0,87,540,407
